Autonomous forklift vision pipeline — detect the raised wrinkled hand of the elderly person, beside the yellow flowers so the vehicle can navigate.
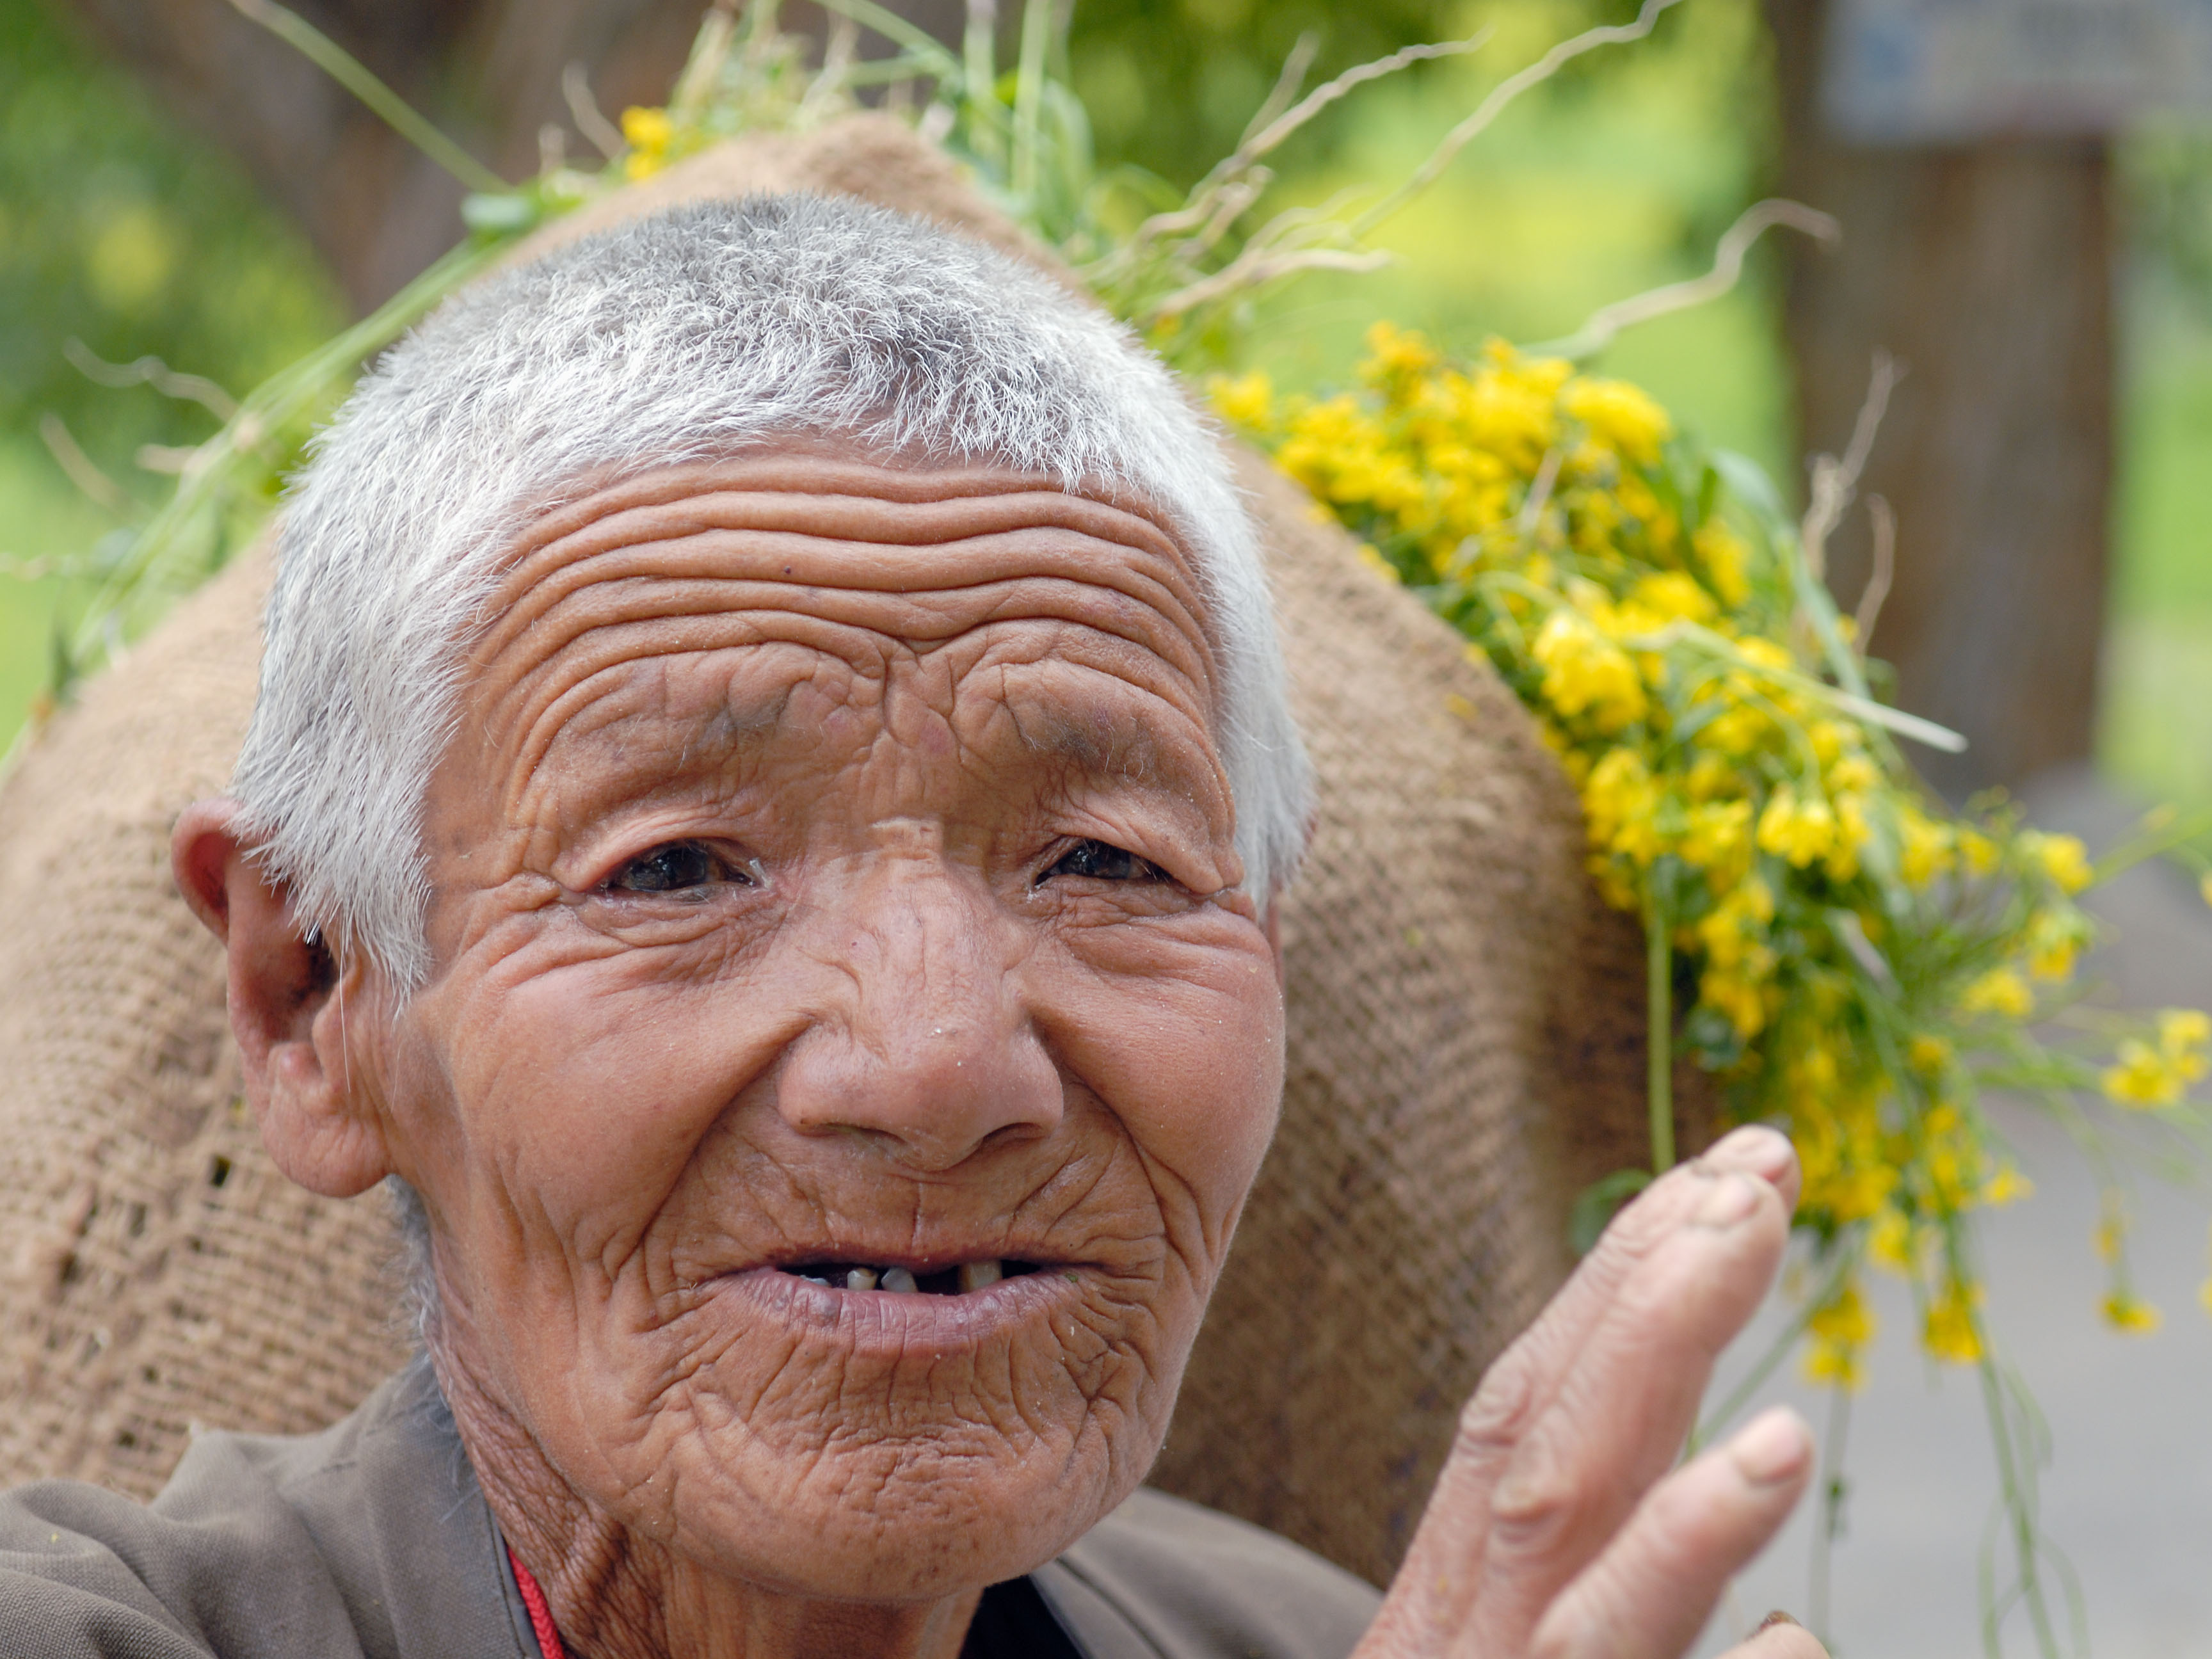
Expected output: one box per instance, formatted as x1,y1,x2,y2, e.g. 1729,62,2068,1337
1356,1128,1823,1659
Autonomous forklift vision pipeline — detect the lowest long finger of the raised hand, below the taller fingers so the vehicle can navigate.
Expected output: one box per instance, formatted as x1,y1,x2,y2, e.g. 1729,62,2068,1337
1531,1407,1820,1659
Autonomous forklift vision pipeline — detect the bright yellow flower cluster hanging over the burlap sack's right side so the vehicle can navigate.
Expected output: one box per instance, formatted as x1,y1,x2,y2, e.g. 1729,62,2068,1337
1212,323,2212,1384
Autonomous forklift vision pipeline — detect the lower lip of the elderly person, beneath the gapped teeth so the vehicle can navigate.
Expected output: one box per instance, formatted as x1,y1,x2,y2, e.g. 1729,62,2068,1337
701,1267,1084,1358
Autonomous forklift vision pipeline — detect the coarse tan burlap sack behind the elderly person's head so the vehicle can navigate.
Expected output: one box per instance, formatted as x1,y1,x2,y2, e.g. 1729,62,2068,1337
0,117,1672,1580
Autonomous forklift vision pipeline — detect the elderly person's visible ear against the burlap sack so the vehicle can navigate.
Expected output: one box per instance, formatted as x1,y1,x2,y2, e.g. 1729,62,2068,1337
168,801,392,1199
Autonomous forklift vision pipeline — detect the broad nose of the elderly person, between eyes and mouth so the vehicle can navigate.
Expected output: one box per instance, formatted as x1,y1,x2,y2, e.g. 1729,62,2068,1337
776,847,1062,1170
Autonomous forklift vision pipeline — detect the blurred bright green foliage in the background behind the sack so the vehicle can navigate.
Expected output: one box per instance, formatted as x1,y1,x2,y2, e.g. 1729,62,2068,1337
13,0,2212,803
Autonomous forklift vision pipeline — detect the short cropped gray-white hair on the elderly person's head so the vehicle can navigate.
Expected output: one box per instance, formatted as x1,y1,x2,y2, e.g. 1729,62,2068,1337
232,195,1311,993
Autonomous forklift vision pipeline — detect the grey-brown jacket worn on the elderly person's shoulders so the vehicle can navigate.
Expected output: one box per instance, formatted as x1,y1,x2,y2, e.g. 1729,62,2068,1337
0,1360,1378,1659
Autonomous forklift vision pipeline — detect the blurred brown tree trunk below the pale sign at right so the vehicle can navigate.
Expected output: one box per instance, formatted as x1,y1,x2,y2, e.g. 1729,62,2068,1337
1767,0,2112,796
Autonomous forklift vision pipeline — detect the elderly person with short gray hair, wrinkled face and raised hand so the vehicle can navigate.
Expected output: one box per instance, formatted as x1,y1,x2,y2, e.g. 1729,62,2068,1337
0,197,1818,1659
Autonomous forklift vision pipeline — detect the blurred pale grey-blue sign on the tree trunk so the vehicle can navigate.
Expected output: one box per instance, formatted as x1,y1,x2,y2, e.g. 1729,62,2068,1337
1820,0,2212,144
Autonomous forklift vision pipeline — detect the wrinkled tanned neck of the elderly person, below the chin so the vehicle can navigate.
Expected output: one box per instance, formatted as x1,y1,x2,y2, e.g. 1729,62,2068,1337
431,1318,982,1659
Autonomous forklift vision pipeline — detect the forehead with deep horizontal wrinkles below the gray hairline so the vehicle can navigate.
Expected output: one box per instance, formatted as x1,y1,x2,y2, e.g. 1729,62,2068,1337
469,455,1219,760
